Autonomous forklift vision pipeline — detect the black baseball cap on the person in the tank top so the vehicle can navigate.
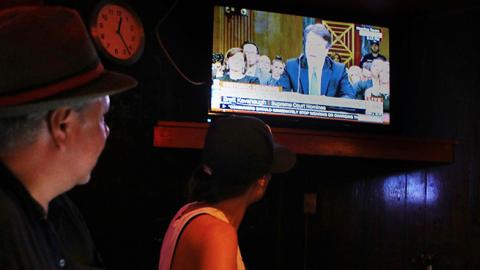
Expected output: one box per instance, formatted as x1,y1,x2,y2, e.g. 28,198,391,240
203,115,296,179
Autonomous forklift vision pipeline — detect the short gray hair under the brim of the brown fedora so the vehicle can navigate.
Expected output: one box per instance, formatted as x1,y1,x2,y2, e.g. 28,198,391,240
0,99,93,154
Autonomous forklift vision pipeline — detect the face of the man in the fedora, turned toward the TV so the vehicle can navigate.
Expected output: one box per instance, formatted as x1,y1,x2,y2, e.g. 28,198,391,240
71,96,110,185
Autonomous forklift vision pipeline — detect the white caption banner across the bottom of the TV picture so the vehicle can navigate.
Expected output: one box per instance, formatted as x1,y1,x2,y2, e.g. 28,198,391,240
211,80,389,124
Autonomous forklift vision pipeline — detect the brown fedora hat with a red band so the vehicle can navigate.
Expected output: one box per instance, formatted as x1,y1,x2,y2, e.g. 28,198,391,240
0,6,137,117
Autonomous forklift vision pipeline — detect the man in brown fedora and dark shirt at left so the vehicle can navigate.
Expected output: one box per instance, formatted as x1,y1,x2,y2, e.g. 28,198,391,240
0,6,137,270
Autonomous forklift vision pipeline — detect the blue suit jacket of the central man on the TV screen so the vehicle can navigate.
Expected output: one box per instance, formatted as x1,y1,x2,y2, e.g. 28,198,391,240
277,54,356,98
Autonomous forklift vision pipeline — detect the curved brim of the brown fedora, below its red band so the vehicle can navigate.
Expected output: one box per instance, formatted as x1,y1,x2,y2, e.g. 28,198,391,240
0,71,138,118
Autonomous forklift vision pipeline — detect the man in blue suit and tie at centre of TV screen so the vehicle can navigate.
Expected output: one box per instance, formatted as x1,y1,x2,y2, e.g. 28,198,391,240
278,24,355,98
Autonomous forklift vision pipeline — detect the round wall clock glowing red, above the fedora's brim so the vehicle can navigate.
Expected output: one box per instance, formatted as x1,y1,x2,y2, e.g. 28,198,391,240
90,2,145,64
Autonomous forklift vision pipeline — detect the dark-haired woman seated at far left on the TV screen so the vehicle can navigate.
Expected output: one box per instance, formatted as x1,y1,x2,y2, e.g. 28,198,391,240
218,48,260,84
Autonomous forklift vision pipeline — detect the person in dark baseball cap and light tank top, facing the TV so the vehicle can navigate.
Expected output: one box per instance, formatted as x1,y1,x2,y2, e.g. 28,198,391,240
159,116,296,270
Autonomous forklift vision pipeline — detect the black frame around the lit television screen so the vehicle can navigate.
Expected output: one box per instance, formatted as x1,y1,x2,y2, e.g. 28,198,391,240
205,2,400,134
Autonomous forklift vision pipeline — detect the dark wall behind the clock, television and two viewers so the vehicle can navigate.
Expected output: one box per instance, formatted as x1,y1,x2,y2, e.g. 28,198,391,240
35,0,480,270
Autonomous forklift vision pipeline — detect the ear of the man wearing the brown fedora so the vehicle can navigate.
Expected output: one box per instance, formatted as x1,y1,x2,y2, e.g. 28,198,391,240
47,107,73,148
